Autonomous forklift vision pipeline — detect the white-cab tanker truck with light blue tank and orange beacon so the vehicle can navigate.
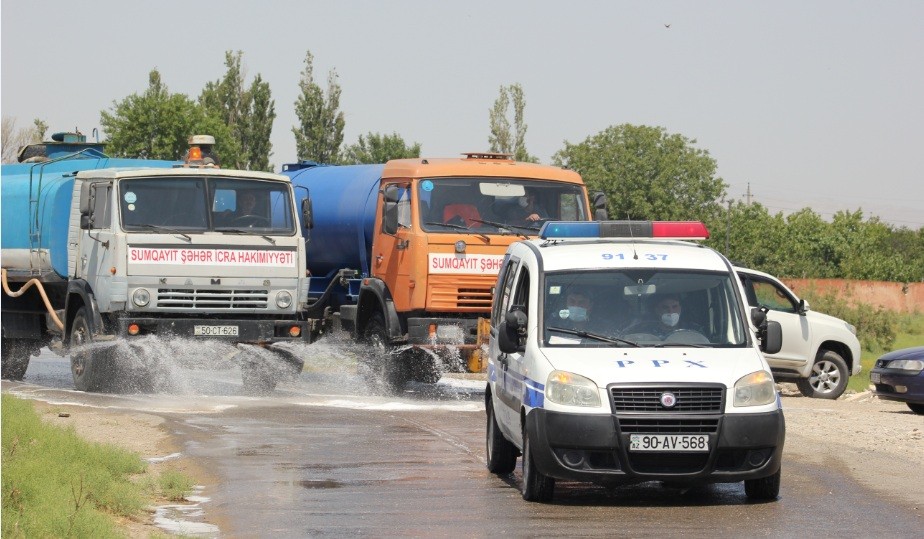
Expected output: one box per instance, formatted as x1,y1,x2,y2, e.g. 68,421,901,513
0,134,311,391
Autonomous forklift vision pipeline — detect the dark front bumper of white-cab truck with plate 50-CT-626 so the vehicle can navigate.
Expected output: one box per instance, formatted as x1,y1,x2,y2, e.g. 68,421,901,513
111,317,315,344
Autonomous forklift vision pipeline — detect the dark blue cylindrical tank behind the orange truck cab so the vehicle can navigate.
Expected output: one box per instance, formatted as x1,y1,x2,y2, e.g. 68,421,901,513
282,163,385,276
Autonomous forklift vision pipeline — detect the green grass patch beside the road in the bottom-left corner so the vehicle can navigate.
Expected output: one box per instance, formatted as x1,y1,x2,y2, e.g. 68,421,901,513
0,395,192,538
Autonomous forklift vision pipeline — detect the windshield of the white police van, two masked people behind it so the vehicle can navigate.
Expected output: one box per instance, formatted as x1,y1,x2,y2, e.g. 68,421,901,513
541,270,747,347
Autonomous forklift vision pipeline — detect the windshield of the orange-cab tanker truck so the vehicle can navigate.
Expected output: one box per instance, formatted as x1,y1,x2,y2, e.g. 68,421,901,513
417,178,588,235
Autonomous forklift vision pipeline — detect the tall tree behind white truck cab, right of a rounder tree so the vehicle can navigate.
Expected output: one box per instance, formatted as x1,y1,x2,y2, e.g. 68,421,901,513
199,51,276,170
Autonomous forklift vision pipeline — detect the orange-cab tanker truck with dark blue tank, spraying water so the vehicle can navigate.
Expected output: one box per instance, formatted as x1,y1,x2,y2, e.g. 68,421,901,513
282,153,605,390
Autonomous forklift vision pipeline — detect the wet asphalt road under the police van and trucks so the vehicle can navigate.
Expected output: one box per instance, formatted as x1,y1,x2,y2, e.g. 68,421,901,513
3,346,924,537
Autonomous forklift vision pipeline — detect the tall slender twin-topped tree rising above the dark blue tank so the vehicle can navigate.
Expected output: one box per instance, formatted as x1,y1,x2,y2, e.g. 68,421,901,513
292,51,346,163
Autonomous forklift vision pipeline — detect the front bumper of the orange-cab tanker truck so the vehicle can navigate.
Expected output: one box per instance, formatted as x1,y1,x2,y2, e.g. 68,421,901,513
407,317,491,372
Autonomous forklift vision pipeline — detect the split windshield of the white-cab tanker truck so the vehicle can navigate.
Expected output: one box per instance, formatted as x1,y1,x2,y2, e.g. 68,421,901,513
119,176,295,235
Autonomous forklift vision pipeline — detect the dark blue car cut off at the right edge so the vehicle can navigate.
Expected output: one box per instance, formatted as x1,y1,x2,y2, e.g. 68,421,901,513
869,346,924,415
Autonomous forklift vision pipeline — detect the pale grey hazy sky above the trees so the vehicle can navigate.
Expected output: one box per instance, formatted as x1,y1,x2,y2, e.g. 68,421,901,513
0,0,924,229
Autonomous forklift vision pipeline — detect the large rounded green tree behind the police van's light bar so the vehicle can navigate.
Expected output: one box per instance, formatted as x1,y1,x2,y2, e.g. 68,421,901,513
553,124,726,221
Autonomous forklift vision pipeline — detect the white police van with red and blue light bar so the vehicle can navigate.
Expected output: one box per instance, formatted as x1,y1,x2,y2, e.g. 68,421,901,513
485,221,785,501
